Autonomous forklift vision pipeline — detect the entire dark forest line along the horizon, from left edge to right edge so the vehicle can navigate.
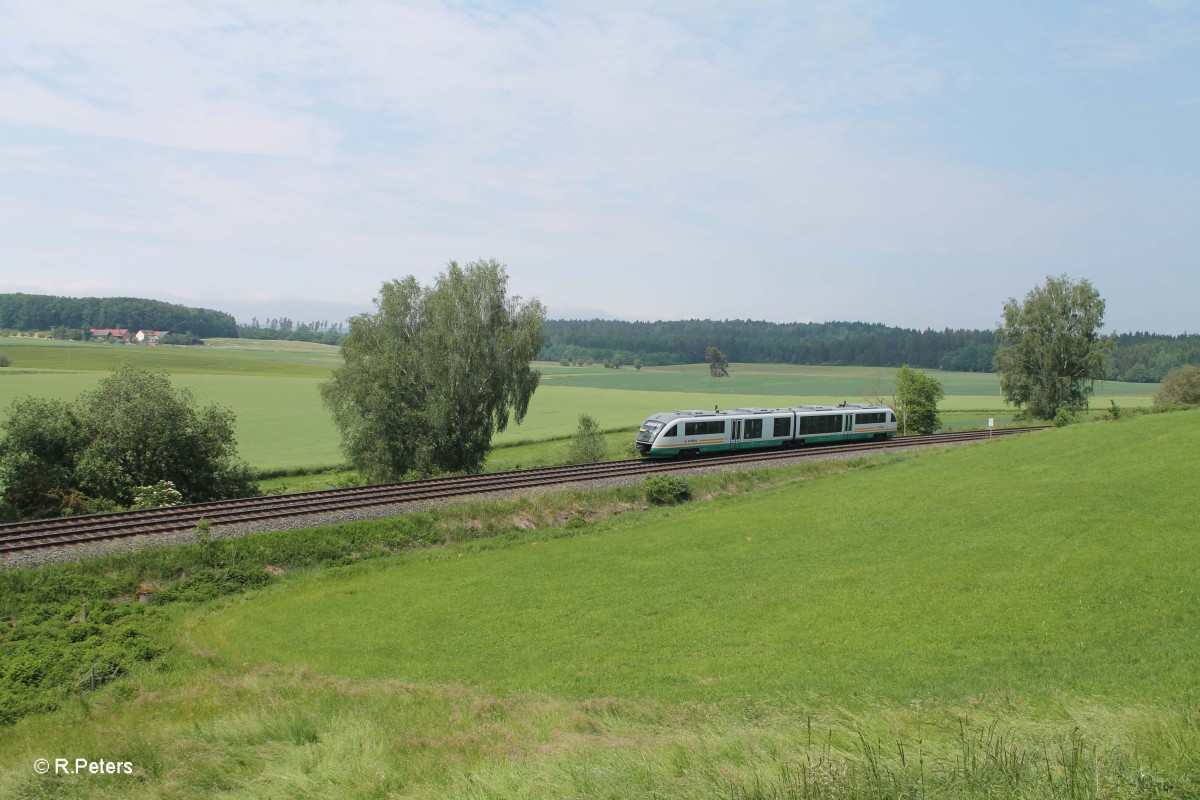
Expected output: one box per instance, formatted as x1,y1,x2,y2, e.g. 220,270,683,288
0,294,1200,383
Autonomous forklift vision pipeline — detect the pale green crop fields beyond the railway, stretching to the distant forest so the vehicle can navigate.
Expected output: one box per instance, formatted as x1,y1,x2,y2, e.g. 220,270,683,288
0,338,1158,470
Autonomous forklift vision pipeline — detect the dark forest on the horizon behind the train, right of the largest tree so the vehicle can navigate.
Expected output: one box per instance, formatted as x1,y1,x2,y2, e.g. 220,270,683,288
539,319,1200,383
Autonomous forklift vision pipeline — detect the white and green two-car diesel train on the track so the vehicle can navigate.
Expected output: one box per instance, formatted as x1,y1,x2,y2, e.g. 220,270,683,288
636,404,896,458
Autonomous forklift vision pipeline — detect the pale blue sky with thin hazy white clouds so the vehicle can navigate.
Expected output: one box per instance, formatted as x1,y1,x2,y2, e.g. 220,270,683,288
0,0,1200,333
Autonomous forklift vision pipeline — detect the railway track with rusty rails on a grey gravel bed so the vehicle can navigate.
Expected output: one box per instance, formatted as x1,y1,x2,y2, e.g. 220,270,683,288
0,428,1034,557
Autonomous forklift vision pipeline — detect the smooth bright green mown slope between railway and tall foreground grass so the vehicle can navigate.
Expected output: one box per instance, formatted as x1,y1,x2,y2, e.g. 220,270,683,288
192,414,1200,702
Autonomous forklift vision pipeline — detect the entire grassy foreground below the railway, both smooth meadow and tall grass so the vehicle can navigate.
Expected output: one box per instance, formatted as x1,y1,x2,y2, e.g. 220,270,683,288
0,411,1200,799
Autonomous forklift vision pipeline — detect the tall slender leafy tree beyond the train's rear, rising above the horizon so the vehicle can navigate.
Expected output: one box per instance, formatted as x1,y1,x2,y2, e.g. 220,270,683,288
995,275,1116,420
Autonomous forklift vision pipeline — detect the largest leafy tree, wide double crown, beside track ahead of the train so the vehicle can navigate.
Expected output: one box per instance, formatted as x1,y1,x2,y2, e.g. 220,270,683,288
322,259,546,481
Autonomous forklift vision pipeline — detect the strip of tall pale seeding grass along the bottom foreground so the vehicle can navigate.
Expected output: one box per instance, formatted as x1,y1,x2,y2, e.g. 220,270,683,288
0,654,1200,800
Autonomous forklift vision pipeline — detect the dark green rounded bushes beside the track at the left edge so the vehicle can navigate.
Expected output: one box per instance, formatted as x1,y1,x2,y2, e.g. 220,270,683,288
0,366,258,518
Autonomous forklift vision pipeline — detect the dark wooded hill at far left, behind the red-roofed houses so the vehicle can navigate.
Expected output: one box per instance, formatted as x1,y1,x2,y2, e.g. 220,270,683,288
0,293,238,338
